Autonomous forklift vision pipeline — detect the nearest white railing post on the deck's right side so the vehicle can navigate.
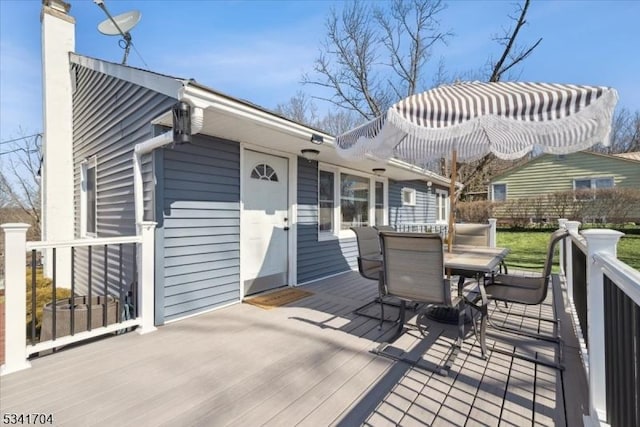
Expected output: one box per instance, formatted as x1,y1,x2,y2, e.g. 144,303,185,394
582,229,624,421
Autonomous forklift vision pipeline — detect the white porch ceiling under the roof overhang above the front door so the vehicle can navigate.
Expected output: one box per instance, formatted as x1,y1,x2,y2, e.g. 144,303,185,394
154,107,449,186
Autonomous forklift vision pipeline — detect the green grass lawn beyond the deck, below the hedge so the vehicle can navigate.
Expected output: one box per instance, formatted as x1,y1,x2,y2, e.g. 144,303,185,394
497,231,640,271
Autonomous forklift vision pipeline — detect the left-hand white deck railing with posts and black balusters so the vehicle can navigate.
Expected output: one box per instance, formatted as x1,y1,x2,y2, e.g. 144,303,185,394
1,222,155,375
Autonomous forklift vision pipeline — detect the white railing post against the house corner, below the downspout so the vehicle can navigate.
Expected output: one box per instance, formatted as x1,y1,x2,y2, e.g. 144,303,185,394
137,221,157,334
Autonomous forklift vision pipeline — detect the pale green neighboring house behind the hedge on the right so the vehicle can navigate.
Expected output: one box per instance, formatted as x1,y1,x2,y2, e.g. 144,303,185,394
489,151,640,219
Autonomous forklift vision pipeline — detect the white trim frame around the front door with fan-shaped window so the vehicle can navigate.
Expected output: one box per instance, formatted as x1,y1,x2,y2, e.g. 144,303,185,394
240,142,298,294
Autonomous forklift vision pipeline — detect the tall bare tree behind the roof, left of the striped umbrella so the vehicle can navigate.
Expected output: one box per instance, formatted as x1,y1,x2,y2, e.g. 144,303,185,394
303,0,451,119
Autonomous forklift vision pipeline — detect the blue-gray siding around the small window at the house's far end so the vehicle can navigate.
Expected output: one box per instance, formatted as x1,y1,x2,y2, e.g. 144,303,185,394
389,180,436,226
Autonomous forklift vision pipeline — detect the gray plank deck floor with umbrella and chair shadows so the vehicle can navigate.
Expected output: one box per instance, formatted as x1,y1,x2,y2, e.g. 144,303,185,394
0,272,587,426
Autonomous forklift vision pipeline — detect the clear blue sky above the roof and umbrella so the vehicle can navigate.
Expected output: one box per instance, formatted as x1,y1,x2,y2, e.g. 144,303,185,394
0,0,640,141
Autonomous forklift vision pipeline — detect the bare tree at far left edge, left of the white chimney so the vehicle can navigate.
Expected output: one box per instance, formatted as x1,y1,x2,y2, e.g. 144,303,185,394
0,134,42,236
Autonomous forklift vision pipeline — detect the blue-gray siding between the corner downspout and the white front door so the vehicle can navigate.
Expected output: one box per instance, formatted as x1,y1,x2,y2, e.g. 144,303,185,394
156,135,240,320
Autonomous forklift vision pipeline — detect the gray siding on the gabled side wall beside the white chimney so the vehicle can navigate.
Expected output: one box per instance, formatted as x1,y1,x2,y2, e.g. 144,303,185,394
73,65,175,295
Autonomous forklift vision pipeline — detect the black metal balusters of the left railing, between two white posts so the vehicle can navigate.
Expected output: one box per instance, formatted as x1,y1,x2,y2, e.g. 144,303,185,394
27,243,138,345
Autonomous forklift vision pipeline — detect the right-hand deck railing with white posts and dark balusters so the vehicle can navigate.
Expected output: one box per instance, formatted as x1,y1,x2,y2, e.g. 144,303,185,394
561,221,640,427
